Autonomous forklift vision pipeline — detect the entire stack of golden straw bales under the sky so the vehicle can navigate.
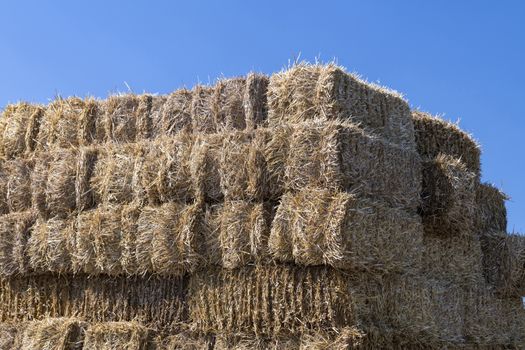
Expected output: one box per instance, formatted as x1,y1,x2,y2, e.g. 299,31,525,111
0,64,525,350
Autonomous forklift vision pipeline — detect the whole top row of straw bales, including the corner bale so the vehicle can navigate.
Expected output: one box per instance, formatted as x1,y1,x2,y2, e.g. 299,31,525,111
0,64,415,159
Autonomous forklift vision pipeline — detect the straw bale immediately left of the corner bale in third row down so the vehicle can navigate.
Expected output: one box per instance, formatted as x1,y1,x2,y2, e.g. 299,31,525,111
201,201,273,269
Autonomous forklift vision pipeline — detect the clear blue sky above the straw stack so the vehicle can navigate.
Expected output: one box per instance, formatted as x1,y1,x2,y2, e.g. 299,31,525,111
0,0,525,232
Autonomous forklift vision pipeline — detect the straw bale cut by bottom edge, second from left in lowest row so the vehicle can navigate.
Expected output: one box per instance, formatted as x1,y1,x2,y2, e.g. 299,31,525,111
20,318,86,350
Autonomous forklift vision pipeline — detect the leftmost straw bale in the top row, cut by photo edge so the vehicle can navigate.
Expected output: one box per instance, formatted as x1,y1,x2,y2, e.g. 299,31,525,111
0,103,44,159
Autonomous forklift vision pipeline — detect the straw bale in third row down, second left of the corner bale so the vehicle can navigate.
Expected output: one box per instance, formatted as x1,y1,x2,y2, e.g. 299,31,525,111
136,203,201,275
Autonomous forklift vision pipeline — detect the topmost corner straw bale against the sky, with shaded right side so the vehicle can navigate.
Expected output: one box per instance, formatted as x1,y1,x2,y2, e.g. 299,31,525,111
268,63,414,149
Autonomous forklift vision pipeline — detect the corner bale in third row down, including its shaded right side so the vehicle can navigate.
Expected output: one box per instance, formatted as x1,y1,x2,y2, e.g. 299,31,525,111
269,188,423,271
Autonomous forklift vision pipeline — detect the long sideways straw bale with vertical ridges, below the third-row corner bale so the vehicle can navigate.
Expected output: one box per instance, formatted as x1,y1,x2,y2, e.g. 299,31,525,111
188,266,352,336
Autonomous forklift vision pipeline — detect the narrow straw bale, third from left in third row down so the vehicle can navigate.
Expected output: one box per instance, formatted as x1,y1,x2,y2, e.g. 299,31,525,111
72,206,123,275
